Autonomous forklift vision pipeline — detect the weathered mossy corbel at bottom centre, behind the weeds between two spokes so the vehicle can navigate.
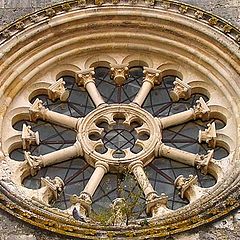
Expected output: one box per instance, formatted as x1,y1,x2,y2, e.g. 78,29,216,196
108,198,127,227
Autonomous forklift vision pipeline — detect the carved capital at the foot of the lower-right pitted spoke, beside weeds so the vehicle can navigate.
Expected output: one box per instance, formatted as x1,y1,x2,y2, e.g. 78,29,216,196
146,193,172,218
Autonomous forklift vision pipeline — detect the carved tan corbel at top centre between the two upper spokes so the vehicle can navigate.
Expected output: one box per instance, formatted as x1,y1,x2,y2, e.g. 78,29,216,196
111,64,128,86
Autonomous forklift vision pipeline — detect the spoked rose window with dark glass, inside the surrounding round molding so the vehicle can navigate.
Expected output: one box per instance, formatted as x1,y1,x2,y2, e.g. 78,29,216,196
7,66,228,221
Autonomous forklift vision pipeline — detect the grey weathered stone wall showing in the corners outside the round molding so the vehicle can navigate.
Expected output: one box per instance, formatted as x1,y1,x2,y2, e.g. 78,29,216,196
0,0,240,240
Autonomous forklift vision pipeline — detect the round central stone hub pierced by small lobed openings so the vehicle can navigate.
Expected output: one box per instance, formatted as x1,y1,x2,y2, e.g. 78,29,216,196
77,104,162,172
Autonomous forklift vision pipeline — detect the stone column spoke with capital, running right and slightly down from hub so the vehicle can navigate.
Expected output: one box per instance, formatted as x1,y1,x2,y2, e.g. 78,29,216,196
157,144,214,174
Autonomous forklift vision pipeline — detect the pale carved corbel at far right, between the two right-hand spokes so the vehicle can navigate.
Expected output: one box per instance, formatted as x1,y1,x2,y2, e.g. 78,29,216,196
198,122,217,148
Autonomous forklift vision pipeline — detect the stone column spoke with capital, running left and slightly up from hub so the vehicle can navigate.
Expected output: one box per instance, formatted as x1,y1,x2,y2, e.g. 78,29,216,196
29,98,81,129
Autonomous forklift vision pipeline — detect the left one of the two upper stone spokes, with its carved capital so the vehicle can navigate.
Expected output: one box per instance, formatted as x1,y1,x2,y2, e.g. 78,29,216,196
77,68,105,107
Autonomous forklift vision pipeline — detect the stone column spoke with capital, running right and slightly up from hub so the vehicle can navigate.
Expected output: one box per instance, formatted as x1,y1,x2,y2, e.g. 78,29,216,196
159,98,210,129
